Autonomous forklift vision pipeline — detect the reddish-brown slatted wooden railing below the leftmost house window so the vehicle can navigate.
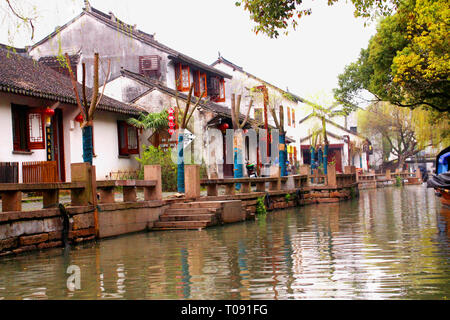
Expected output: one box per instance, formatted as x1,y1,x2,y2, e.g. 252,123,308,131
22,161,59,183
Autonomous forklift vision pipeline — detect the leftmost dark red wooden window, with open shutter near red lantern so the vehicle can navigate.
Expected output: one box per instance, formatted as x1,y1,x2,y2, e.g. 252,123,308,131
11,104,46,151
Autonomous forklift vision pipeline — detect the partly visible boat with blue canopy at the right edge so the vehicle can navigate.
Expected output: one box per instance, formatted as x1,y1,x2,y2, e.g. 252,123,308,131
427,146,450,208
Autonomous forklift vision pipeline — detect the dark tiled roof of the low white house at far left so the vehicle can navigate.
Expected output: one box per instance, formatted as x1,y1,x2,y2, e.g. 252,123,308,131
0,48,143,115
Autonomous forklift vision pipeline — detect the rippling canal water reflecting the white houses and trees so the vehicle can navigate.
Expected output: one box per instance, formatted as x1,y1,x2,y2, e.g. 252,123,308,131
0,186,450,299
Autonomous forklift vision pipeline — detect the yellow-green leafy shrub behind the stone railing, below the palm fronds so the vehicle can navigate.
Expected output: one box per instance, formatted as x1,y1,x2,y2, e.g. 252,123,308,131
136,146,177,192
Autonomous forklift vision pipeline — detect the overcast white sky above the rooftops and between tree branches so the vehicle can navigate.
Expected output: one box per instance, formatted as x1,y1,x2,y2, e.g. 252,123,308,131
0,0,375,98
